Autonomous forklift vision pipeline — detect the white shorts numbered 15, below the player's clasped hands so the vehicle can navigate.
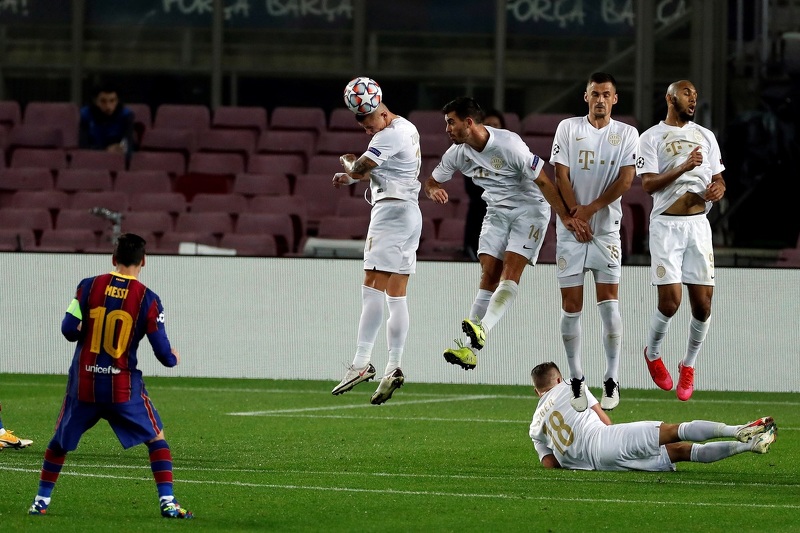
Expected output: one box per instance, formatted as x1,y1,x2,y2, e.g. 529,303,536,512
556,228,622,287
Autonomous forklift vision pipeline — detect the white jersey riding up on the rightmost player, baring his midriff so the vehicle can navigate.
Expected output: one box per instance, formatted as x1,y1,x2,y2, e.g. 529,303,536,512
636,121,725,219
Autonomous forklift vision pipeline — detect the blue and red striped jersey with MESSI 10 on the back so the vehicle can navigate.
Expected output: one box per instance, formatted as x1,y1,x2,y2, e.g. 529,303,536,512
61,272,177,403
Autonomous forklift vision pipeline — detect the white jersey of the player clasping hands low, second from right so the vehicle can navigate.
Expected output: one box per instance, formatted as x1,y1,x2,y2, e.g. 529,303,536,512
550,116,639,236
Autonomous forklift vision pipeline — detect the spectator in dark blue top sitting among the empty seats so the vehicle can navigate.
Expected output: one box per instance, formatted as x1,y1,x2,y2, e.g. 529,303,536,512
78,82,134,158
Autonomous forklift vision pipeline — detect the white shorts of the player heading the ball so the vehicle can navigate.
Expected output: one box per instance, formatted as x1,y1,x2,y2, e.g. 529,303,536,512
364,198,422,274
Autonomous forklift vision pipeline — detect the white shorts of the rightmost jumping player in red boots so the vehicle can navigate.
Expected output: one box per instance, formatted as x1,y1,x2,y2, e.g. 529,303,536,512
650,214,714,287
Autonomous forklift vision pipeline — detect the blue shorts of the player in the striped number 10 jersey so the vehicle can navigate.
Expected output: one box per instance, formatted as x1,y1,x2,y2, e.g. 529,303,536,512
53,394,164,452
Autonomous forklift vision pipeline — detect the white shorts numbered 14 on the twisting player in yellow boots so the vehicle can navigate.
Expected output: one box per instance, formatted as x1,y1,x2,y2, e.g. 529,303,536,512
478,202,550,265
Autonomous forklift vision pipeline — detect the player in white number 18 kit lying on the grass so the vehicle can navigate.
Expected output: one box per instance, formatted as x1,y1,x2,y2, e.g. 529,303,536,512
530,362,778,472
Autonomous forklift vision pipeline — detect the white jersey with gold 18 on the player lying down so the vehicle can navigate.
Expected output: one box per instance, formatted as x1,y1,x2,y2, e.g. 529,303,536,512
529,381,606,470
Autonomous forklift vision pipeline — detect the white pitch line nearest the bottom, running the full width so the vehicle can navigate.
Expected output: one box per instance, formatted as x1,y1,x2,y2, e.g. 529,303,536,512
0,466,800,509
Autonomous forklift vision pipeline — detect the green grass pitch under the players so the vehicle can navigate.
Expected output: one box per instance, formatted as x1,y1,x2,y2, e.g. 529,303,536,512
0,374,800,533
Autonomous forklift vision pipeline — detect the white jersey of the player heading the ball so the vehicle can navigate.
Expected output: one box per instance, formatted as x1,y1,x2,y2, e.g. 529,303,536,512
363,117,422,203
